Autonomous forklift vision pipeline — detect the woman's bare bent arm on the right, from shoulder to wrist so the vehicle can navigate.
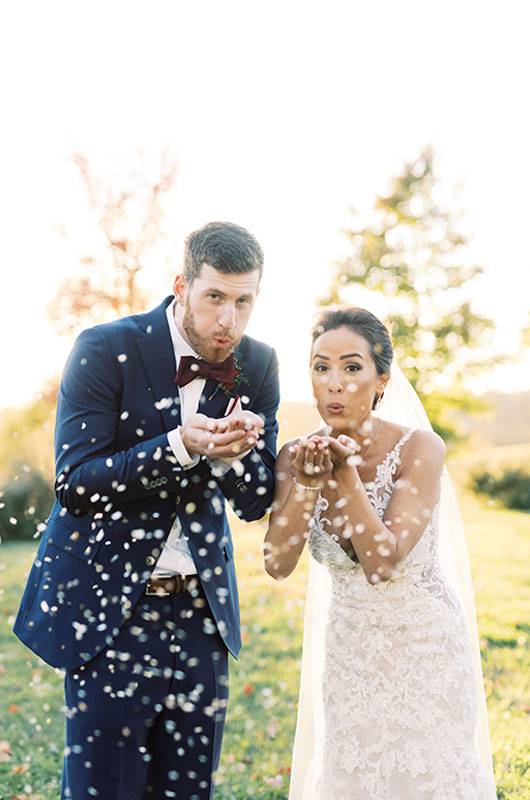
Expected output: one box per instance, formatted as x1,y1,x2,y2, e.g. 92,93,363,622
333,431,445,583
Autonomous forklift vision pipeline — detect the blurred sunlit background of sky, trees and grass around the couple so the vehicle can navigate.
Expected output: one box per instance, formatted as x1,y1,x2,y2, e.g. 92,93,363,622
0,0,530,800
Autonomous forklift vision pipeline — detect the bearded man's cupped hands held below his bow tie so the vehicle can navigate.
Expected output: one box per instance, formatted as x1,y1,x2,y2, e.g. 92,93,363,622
180,411,263,458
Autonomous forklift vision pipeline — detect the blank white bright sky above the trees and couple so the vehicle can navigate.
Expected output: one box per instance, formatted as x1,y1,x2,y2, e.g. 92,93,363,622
0,0,530,405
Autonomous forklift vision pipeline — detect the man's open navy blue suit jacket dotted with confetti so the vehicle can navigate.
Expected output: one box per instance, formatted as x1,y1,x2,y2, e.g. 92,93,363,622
14,297,279,669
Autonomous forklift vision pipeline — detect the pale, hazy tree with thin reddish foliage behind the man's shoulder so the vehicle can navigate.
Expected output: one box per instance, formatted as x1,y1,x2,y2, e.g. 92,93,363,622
48,150,177,335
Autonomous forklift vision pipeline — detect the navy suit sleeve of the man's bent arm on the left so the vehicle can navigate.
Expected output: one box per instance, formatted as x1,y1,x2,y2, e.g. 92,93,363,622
55,328,208,516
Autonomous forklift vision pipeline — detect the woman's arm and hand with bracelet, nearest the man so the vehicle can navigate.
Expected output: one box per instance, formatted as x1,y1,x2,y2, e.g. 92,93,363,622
263,441,332,580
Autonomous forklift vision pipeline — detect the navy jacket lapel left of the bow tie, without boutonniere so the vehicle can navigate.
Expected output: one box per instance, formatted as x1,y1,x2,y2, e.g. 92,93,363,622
137,297,180,431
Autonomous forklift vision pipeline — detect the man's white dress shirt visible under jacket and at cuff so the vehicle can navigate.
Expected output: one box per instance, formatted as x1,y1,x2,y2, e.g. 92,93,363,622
151,300,231,577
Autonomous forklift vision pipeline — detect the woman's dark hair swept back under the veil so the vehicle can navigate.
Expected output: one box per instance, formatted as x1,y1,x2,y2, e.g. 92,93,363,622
311,306,394,408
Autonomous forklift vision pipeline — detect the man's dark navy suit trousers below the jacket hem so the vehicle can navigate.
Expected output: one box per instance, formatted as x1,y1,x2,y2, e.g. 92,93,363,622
61,579,228,800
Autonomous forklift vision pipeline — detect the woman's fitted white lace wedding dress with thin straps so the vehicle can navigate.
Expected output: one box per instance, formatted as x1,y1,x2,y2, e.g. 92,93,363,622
309,430,491,800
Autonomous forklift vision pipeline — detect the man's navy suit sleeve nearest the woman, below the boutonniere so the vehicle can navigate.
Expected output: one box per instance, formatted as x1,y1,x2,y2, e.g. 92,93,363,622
217,350,280,522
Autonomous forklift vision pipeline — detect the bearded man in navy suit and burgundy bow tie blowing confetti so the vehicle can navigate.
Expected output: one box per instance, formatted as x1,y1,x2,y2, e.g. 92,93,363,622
14,222,279,800
